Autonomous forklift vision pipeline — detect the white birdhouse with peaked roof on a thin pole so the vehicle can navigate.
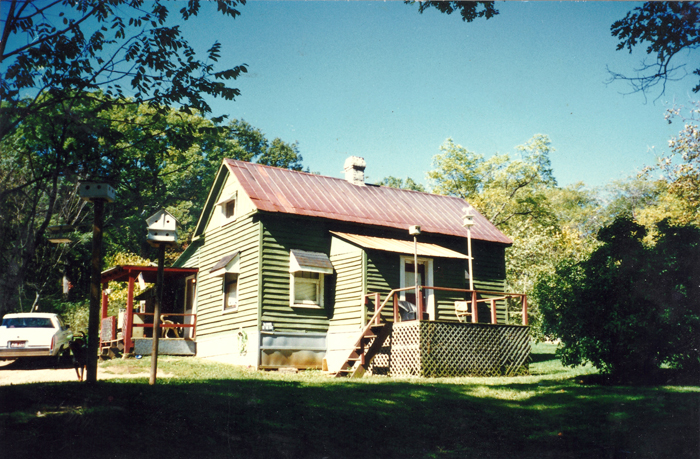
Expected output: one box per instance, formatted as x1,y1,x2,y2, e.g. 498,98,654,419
146,209,177,385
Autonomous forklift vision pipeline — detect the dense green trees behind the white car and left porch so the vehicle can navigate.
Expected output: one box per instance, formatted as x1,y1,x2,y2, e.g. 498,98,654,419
0,93,302,312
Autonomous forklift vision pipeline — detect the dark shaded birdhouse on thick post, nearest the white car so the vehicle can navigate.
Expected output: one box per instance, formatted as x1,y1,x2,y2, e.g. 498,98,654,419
78,181,116,383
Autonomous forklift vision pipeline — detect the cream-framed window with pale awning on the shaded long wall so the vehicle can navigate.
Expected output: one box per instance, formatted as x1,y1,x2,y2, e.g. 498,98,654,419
289,250,333,308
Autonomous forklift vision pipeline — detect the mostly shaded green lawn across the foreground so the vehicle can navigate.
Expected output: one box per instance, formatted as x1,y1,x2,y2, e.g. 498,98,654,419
0,344,700,459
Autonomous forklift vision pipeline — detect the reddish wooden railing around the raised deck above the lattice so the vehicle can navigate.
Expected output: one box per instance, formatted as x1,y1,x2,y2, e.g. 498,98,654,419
363,286,529,325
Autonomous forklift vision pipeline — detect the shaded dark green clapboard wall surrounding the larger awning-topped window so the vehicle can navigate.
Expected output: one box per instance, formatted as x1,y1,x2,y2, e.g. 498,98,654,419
261,215,335,333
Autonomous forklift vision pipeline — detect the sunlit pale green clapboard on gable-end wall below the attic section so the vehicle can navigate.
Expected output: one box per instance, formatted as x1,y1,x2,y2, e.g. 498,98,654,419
197,215,260,337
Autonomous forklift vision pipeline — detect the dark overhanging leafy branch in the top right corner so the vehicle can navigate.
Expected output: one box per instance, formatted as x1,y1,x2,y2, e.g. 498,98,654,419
611,2,700,94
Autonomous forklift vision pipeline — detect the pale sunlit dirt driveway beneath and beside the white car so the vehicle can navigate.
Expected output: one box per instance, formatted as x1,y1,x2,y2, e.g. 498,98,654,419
0,359,169,386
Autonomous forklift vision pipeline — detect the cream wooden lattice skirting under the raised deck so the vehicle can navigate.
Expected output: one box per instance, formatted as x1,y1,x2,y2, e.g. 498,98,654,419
369,321,530,377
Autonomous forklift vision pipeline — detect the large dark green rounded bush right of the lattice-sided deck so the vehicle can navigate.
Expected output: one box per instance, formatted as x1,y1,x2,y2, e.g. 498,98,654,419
534,217,700,378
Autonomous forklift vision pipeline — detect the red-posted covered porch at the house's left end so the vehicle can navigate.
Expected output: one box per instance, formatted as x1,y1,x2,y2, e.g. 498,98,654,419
100,265,198,356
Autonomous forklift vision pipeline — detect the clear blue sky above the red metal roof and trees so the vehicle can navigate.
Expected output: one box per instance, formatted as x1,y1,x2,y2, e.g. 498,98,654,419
184,1,698,187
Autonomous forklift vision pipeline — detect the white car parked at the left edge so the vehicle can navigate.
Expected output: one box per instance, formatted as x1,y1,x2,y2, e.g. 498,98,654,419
0,312,73,360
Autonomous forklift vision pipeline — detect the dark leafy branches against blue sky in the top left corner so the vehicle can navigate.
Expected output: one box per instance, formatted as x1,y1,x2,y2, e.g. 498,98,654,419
0,0,246,139
